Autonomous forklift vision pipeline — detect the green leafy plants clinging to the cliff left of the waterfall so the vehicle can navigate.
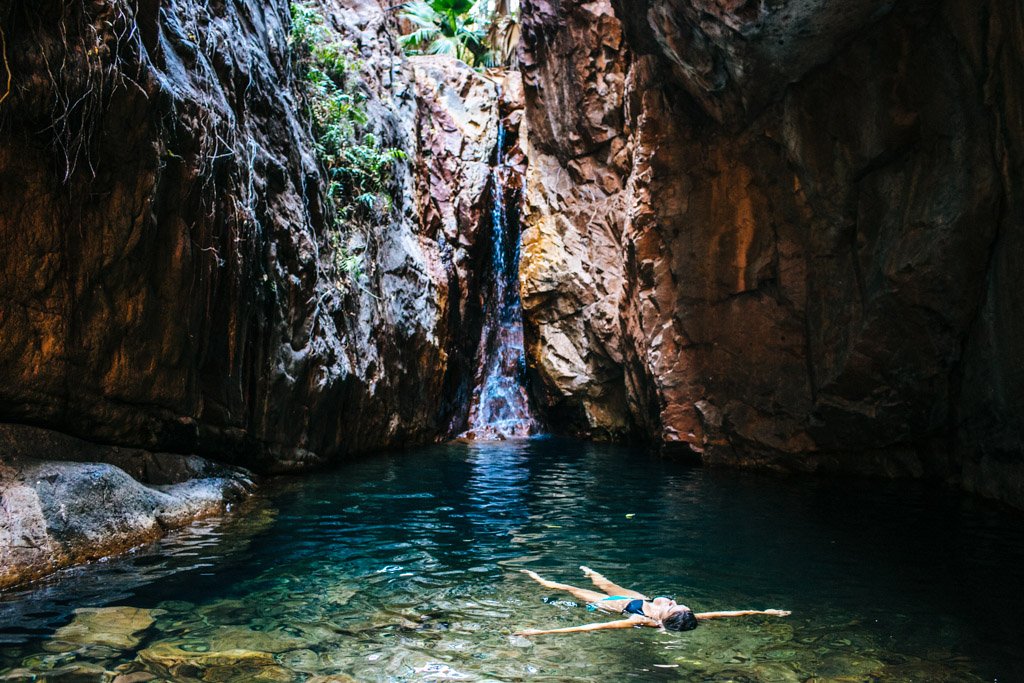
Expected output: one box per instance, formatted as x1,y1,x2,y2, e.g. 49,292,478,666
289,2,406,286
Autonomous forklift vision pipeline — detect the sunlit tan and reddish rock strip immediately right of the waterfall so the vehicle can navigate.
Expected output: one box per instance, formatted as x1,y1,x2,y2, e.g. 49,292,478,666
520,1,633,438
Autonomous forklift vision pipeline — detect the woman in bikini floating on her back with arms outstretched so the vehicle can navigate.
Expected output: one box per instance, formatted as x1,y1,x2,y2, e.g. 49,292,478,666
515,566,792,636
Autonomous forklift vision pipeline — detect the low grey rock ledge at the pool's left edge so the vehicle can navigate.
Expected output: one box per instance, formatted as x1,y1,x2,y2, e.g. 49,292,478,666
0,425,255,590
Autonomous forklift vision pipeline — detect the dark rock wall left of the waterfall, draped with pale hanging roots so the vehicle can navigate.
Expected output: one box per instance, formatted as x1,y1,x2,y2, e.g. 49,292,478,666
0,0,498,471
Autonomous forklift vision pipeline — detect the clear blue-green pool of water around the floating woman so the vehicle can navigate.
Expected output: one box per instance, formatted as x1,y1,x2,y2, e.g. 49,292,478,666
0,439,1024,682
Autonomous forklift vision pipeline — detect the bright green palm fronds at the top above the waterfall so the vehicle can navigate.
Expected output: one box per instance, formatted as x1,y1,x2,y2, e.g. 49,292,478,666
400,0,519,67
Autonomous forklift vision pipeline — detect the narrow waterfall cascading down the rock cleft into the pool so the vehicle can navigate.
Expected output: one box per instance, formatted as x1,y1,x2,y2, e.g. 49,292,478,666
464,126,538,439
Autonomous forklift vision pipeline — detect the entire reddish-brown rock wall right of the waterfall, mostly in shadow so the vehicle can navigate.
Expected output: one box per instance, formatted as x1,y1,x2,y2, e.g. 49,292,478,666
521,0,1024,504
